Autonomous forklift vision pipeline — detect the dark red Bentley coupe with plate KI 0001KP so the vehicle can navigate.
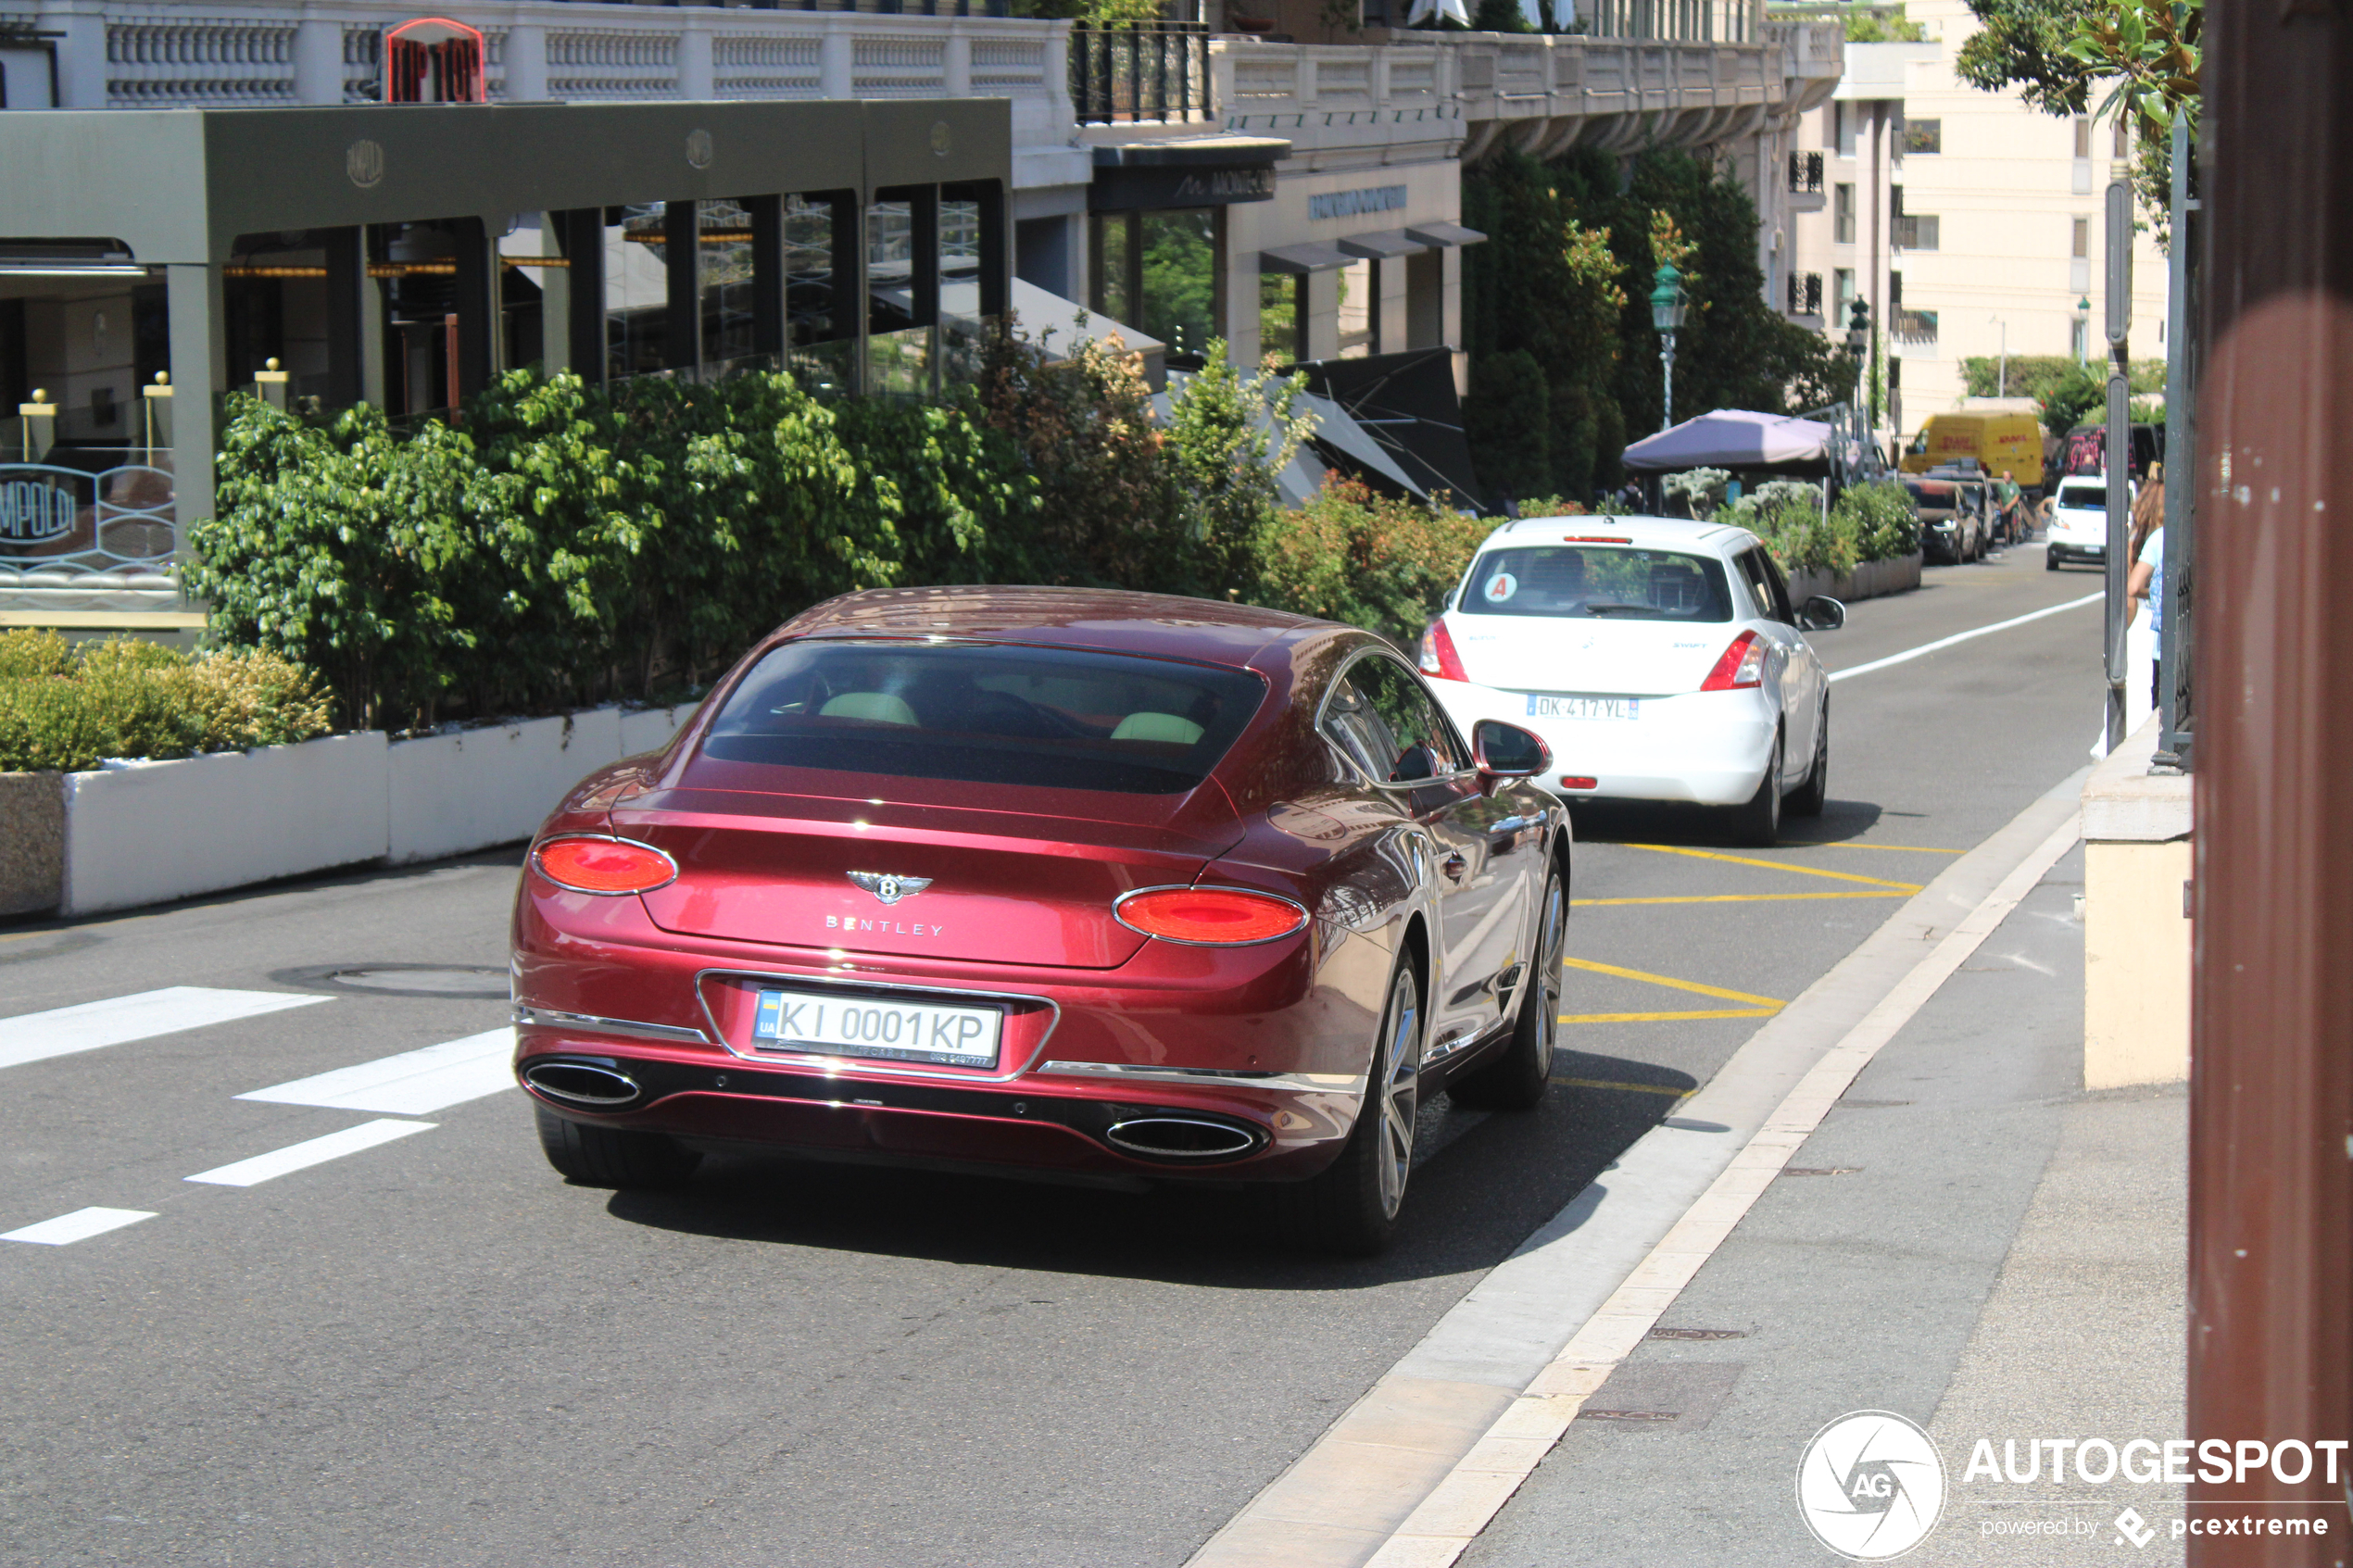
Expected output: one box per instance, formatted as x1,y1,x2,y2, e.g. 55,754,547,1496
513,588,1569,1250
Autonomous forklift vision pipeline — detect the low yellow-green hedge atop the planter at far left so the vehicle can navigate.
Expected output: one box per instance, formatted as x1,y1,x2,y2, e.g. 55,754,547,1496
0,633,330,773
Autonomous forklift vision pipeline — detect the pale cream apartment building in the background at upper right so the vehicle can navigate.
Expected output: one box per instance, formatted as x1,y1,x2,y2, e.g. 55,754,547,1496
1786,0,2165,435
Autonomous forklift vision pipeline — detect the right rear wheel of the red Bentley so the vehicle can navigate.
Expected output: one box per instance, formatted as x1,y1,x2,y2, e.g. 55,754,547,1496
1276,957,1428,1258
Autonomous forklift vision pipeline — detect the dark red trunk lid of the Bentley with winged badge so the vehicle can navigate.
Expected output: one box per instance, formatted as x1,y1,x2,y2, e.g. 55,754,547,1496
611,781,1242,969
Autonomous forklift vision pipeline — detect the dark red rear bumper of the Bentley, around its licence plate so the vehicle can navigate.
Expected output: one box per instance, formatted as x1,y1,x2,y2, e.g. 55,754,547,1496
515,886,1389,1180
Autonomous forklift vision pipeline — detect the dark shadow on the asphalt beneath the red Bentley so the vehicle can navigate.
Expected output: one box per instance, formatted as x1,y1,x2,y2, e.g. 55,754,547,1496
607,1051,1696,1290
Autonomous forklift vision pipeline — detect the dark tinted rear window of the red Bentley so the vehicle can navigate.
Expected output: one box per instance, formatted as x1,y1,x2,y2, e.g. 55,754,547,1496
703,639,1266,795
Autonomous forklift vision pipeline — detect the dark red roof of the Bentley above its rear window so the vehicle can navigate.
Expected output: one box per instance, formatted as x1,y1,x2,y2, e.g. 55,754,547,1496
772,583,1346,668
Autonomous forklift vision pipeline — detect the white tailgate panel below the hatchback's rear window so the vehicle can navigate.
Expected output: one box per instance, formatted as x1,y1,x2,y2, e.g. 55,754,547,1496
1447,611,1742,696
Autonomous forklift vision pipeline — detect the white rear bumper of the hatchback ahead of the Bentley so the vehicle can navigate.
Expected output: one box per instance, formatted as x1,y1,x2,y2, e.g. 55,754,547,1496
1430,680,1779,807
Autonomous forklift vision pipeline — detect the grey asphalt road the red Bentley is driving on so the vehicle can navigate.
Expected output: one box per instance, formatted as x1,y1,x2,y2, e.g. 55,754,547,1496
0,547,2099,1568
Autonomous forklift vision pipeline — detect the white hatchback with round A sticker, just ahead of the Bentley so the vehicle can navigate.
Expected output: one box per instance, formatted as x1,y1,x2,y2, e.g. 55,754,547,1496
1421,517,1847,844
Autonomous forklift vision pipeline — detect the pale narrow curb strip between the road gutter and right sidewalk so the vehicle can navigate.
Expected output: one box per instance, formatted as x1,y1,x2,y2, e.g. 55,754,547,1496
1367,816,2082,1568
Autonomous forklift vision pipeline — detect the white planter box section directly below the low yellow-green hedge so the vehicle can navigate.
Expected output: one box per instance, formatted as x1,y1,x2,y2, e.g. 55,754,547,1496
59,731,386,914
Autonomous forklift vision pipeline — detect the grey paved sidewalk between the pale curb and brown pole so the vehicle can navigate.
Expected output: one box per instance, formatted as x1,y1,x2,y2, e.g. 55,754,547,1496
1461,847,2186,1568
